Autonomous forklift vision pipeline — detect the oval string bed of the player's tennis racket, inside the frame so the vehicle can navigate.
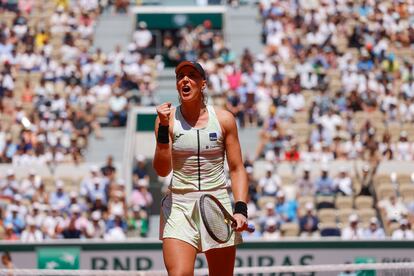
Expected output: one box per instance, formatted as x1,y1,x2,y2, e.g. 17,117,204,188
203,197,231,242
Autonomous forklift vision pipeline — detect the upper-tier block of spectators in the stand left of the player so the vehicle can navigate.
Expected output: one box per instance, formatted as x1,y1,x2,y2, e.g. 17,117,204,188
0,1,159,167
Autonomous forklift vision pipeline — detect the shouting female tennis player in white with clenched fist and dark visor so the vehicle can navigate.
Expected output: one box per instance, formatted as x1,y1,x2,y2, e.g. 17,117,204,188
153,61,248,275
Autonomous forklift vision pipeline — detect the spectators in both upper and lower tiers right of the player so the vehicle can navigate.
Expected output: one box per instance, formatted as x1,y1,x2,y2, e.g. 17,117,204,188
236,1,414,239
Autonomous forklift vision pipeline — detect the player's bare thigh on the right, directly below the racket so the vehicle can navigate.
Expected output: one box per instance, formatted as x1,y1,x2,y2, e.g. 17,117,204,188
205,246,236,276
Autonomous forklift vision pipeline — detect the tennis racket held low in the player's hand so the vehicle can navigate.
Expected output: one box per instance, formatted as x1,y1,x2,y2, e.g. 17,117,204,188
199,194,255,243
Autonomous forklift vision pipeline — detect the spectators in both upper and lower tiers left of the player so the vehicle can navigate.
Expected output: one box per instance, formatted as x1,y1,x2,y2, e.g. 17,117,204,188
0,0,162,241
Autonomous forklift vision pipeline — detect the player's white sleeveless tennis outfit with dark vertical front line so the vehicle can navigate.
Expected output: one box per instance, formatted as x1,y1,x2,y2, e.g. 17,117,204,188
160,105,242,252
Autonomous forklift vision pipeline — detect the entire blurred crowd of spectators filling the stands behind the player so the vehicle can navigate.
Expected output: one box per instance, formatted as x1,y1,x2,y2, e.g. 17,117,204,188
0,0,414,241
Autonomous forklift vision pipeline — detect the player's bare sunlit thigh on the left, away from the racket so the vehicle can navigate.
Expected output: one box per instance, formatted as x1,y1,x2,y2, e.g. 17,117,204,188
162,238,197,276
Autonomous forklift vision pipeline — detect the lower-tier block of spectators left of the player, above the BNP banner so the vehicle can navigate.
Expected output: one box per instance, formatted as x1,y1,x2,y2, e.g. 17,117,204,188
0,156,153,242
